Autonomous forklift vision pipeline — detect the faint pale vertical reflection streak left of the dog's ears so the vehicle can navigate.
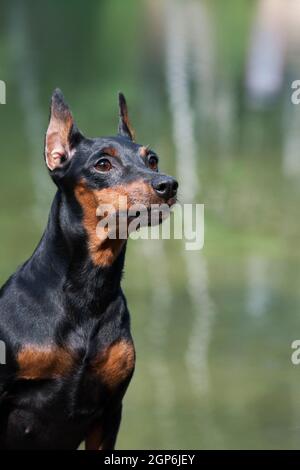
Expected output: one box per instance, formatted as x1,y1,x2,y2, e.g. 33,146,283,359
9,1,50,227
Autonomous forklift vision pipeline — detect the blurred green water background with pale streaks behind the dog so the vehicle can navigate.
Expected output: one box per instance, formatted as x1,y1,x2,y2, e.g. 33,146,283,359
0,0,300,449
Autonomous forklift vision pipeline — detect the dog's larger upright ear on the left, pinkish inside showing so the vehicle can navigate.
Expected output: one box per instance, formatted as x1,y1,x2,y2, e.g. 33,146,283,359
45,88,83,171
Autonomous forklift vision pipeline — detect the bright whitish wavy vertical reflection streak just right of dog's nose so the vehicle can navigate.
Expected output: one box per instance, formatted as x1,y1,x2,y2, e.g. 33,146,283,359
166,0,213,393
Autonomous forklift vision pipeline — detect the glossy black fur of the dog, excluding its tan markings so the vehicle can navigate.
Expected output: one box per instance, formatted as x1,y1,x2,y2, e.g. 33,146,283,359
0,90,176,449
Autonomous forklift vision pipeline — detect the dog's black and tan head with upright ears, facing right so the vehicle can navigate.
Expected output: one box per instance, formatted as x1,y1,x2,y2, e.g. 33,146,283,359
45,89,178,264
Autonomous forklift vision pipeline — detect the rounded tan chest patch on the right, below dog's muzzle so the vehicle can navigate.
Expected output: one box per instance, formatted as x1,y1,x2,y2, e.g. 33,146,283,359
92,340,135,388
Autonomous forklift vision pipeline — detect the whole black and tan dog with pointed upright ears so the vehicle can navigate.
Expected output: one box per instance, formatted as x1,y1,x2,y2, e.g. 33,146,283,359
0,90,177,449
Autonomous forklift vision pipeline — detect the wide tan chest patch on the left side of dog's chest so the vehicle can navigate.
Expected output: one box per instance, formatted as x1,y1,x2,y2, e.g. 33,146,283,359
17,345,74,380
